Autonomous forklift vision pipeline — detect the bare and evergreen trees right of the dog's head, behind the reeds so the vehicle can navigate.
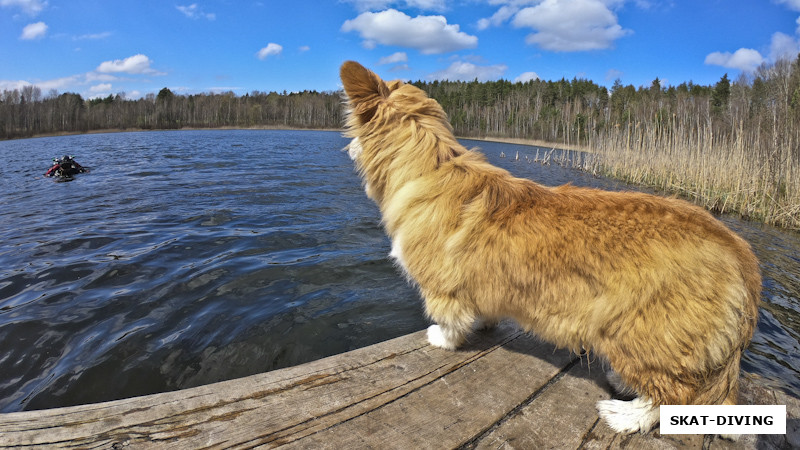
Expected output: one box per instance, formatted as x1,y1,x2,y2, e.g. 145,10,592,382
414,56,800,151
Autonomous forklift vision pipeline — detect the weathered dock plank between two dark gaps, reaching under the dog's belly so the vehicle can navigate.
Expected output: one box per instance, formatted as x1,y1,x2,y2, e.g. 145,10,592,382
280,326,573,449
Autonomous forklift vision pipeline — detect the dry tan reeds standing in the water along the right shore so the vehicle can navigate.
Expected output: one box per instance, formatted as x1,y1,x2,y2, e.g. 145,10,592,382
576,118,800,230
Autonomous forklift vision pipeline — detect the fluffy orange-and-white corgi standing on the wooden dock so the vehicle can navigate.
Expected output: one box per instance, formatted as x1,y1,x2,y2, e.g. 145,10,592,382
341,61,761,432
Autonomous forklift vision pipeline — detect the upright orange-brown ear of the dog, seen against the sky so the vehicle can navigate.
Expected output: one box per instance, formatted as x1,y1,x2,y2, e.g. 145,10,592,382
339,61,390,123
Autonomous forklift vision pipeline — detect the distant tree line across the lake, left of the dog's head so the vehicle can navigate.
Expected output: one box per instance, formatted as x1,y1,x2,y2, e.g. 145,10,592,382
0,86,343,139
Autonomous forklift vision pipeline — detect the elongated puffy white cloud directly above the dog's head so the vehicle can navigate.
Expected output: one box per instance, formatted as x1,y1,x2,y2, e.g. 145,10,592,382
342,9,478,55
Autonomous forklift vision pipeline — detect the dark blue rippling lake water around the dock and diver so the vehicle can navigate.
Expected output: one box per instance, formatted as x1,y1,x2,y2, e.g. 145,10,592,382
0,130,800,412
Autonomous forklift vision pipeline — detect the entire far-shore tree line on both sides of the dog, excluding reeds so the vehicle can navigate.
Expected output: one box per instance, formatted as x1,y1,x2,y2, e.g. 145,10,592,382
0,56,800,149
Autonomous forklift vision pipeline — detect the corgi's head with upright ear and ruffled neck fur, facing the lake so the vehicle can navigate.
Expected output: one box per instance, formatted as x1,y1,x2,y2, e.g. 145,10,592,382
340,61,466,202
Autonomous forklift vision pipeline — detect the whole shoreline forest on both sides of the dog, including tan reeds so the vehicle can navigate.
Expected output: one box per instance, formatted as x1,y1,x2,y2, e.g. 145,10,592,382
0,55,800,229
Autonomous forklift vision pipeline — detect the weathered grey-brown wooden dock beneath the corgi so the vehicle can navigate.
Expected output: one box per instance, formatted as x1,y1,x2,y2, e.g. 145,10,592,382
0,325,800,449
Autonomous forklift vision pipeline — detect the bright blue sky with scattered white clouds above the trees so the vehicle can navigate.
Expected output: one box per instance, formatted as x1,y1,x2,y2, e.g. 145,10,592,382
0,0,800,98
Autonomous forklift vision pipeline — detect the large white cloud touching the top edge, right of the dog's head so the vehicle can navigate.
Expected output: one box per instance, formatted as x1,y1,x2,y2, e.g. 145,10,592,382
512,0,632,52
